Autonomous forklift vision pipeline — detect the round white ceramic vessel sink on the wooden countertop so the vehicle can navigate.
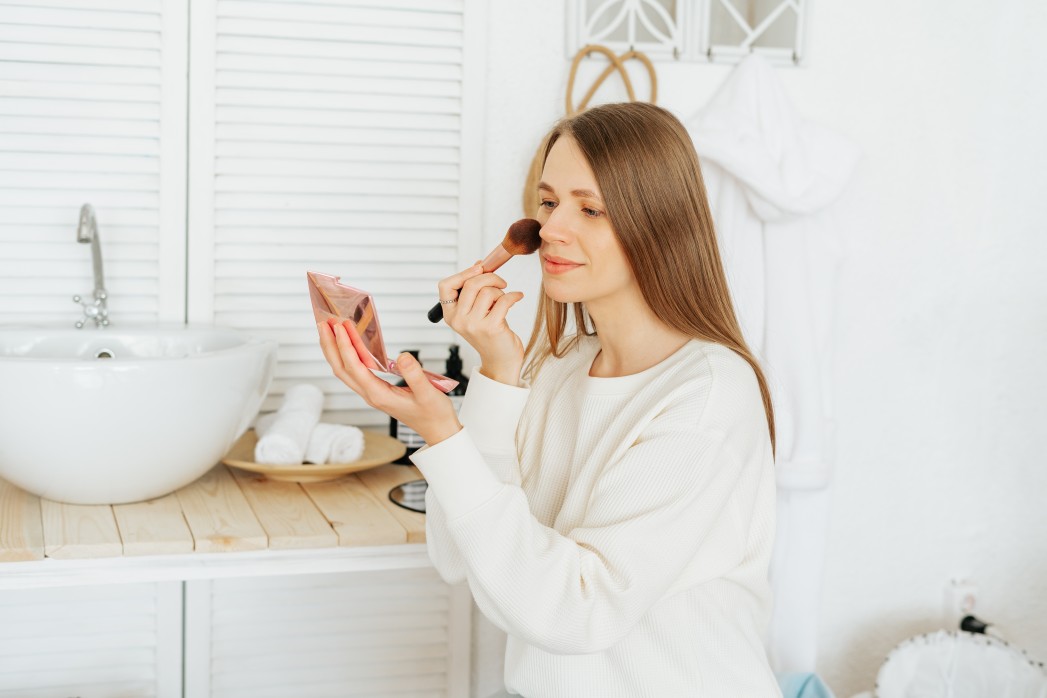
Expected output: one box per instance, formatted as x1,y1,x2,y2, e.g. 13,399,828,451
0,325,276,504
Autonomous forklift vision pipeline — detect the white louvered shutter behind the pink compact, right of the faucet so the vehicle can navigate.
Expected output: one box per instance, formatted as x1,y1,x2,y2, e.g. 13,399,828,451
188,0,478,424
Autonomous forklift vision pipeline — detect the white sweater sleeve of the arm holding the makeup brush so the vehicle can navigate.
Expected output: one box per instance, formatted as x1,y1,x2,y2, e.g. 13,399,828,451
411,370,530,584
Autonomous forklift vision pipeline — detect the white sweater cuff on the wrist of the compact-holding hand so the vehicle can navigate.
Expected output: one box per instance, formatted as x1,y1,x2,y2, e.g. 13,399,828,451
410,426,503,520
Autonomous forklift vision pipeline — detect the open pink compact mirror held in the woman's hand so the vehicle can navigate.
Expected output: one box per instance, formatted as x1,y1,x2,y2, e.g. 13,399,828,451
306,271,458,392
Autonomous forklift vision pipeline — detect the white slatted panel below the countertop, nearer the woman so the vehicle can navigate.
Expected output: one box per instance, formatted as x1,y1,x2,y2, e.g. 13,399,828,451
202,568,452,698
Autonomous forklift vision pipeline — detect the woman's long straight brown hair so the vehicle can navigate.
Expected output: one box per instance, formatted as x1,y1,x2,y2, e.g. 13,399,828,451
525,102,775,456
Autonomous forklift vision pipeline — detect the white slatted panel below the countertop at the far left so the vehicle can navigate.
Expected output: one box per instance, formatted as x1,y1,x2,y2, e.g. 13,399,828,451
0,583,181,698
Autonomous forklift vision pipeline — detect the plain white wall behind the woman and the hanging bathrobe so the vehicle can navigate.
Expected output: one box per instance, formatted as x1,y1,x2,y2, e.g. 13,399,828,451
474,0,1047,696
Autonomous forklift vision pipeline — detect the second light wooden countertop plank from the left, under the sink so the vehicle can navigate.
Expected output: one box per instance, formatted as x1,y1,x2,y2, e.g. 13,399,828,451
40,499,124,560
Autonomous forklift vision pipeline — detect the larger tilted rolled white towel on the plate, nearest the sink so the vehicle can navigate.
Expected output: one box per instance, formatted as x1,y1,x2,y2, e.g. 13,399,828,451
254,383,324,466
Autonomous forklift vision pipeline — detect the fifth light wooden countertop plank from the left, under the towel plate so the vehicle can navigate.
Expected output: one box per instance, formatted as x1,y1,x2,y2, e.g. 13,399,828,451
229,468,338,549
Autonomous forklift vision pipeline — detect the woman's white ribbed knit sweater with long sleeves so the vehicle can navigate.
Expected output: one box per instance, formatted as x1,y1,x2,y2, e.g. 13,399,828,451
413,338,781,698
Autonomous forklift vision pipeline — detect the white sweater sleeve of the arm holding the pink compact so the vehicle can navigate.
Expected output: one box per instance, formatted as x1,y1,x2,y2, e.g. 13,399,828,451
416,410,758,654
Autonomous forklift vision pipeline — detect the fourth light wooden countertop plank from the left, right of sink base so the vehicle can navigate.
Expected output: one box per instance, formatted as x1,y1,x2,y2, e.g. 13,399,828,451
175,466,269,553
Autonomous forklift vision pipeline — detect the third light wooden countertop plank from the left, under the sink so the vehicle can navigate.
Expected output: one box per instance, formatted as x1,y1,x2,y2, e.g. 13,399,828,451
113,494,193,556
